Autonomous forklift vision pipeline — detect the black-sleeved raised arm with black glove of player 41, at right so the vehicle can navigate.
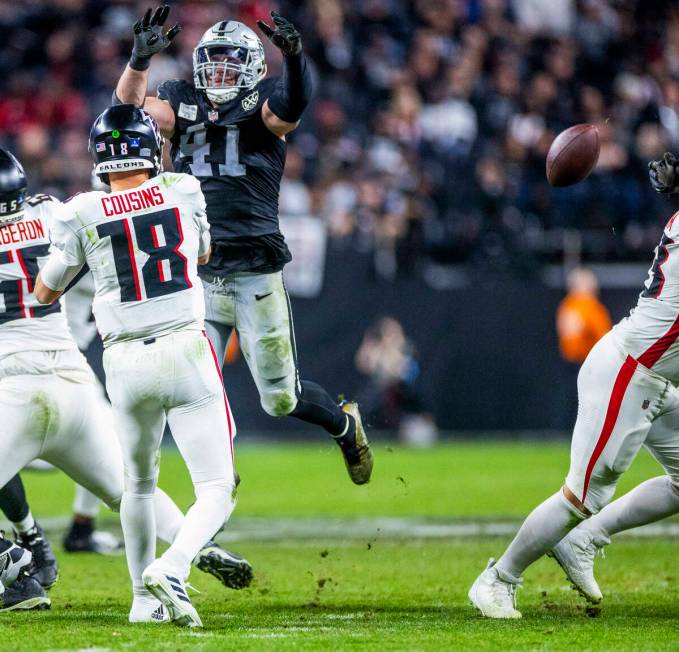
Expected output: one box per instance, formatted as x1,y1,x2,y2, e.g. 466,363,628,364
257,11,311,136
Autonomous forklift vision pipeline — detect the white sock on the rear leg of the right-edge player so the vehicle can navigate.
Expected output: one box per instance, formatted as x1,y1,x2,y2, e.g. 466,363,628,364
579,475,679,541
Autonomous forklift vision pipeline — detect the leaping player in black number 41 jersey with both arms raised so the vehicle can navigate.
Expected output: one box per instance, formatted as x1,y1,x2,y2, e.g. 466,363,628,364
114,6,373,484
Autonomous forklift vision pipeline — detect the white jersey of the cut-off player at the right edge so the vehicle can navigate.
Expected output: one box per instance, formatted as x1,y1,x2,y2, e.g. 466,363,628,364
613,212,679,385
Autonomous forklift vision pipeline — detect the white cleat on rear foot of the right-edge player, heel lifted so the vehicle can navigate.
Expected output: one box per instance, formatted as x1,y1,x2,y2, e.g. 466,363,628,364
547,527,611,604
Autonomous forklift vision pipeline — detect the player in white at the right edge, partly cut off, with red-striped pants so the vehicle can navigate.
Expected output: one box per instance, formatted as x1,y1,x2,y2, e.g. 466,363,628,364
469,152,679,618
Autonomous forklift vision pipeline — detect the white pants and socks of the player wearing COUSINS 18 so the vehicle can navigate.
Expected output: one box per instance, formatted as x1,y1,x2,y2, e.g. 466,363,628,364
104,330,235,594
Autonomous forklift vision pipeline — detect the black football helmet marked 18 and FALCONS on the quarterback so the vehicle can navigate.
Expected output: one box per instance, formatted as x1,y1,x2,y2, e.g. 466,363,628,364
89,104,163,183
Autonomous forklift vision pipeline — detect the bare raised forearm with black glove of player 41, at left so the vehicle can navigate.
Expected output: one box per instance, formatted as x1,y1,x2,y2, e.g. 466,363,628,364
113,5,181,136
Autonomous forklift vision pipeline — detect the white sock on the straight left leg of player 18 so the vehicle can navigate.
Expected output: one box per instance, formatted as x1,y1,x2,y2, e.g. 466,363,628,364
120,491,156,595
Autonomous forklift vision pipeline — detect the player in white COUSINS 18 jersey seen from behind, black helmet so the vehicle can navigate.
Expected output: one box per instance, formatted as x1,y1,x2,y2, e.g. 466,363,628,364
35,104,235,626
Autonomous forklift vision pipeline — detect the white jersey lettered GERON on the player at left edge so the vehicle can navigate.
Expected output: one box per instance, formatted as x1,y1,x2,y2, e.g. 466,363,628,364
0,195,75,358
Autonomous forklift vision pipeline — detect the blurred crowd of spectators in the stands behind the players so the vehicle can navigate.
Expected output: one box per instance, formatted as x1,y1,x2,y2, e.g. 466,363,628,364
0,0,679,279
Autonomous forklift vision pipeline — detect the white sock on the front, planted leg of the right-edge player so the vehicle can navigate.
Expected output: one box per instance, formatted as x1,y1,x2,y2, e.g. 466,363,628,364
495,489,585,579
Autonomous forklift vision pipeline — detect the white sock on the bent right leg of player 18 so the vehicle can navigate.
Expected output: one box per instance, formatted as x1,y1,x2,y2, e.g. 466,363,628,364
160,483,235,579
